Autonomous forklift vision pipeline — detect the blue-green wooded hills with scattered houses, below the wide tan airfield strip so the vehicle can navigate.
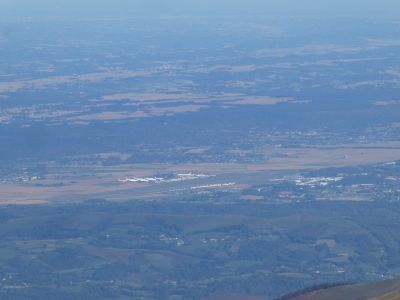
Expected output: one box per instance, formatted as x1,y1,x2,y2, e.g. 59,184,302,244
0,199,400,299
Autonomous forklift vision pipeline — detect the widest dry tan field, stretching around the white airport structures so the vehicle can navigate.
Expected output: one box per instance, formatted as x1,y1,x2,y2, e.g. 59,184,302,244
0,143,400,205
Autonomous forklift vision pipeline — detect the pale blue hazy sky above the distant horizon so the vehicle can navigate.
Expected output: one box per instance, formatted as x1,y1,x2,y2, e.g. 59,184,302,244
0,0,400,18
